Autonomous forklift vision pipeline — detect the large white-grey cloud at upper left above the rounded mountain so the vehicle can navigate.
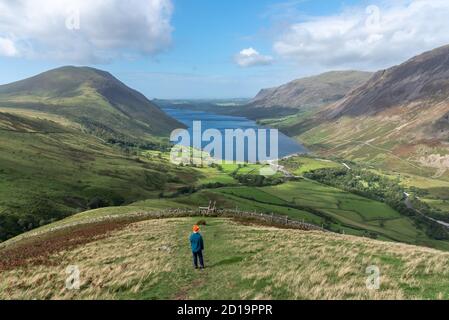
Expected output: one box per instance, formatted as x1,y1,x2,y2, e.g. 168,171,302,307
0,0,173,62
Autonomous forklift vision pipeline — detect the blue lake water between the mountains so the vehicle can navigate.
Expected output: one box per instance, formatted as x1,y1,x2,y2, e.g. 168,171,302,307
163,108,308,160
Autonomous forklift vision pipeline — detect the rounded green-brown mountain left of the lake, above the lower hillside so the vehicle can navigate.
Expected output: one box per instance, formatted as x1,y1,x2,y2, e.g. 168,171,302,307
0,67,183,143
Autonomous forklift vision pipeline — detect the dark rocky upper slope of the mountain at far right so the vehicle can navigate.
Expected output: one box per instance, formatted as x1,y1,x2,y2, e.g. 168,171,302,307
330,46,449,120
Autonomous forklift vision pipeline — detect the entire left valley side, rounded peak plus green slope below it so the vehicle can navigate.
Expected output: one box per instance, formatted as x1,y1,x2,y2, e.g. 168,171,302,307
0,67,197,242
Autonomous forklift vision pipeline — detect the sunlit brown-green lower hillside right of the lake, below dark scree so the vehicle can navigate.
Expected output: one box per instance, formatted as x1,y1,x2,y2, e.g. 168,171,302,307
269,114,449,220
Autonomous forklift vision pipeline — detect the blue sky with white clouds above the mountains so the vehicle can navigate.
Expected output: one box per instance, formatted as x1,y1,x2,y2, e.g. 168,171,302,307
0,0,449,99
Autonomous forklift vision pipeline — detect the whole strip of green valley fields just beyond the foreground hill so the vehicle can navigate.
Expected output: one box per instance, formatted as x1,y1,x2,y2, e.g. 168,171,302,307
171,180,449,250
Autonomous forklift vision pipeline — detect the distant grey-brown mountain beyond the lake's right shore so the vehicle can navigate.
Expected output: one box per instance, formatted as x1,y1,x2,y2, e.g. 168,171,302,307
242,71,372,117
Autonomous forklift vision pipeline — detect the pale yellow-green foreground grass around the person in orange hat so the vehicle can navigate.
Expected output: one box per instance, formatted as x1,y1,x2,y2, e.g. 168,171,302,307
0,218,449,300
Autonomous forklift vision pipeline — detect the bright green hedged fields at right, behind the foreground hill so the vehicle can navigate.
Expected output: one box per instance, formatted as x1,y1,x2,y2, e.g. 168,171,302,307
264,180,449,250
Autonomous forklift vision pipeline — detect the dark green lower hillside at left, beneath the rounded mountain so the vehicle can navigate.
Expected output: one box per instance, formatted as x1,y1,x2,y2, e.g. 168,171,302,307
0,113,201,241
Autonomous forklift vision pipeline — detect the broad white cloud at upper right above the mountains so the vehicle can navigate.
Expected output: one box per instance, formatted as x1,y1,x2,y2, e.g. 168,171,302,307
274,0,449,69
